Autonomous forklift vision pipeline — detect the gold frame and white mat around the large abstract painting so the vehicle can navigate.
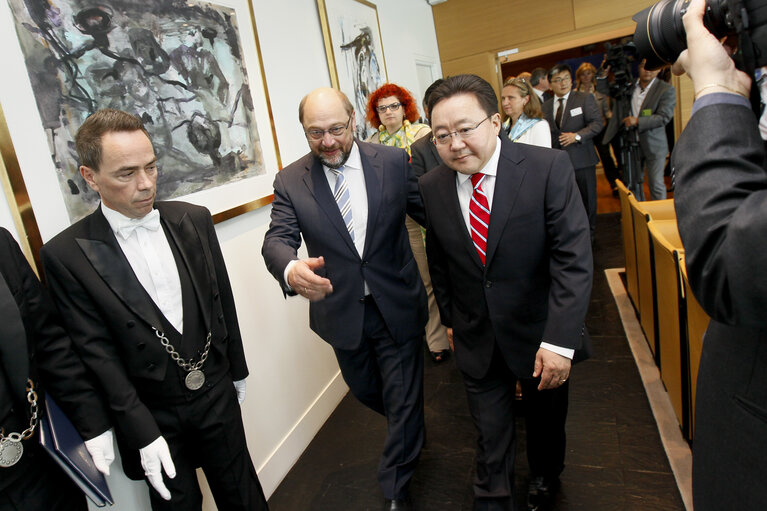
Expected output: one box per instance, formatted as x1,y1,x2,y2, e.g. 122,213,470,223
0,0,282,257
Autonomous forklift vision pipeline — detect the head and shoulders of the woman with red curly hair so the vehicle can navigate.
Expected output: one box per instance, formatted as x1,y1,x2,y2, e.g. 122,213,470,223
367,83,431,154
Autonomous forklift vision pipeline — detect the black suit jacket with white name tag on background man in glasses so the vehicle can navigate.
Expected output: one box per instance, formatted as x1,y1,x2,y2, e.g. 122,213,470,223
541,90,604,169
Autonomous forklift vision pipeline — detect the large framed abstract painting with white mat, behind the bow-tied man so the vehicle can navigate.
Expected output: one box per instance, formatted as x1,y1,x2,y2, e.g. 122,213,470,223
0,0,280,244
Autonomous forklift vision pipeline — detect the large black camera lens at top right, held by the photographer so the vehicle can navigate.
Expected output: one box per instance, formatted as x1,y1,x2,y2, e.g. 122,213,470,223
633,0,687,69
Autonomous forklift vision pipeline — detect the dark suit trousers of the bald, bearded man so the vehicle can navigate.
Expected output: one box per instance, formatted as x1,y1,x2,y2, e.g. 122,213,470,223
335,298,424,499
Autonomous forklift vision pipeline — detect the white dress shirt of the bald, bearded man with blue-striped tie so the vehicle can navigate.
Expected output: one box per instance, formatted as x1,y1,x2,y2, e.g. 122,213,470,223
283,142,370,295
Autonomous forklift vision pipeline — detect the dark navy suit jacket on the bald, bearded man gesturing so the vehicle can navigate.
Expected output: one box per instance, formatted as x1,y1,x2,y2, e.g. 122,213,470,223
261,141,427,349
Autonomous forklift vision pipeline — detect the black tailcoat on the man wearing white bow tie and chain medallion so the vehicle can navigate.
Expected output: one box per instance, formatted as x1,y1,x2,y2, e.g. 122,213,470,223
41,202,248,449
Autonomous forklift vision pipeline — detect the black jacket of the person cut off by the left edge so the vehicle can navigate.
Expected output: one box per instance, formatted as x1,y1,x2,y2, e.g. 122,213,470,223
0,228,110,489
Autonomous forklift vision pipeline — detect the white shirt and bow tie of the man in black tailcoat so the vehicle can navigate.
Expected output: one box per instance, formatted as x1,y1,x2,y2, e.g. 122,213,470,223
101,202,184,334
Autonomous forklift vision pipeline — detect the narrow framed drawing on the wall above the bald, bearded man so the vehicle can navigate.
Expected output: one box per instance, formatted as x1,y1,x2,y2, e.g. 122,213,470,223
317,0,388,140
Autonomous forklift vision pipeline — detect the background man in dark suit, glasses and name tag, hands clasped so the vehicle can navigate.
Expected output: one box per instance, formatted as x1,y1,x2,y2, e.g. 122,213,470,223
541,64,604,239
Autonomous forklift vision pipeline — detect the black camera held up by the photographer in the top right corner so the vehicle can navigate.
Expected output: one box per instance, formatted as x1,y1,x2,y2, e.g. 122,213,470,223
633,0,767,75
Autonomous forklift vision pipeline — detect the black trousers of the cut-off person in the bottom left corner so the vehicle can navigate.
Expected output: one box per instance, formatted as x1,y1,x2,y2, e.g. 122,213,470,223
0,442,88,511
